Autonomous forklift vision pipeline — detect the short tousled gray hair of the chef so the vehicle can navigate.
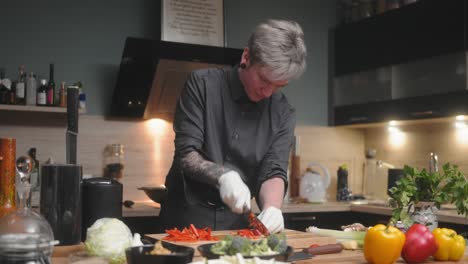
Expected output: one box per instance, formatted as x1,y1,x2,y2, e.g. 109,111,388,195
247,20,307,80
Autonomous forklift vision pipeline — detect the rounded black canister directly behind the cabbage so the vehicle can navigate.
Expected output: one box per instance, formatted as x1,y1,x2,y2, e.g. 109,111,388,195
81,177,123,241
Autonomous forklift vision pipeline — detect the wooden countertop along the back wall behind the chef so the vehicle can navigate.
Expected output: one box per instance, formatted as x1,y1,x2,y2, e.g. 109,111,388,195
123,202,468,225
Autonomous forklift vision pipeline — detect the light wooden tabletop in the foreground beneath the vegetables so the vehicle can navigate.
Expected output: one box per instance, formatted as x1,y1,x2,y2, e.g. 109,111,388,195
52,230,468,264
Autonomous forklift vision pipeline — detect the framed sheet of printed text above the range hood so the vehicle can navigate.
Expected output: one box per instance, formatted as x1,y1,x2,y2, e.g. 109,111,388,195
161,0,224,47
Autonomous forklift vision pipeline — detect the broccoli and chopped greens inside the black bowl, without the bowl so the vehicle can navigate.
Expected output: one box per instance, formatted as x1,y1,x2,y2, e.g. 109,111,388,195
211,234,287,256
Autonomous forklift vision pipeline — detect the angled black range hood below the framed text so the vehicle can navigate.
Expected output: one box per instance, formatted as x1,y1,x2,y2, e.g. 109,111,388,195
111,38,242,120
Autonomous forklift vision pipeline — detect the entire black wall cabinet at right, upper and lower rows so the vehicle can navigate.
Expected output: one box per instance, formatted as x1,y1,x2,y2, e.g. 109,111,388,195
330,0,468,125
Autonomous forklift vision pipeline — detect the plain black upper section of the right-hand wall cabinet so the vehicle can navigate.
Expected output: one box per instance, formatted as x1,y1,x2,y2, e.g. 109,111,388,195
333,0,466,75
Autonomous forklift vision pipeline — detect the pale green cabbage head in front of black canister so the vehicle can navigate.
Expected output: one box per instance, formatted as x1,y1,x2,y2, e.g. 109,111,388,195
85,218,133,264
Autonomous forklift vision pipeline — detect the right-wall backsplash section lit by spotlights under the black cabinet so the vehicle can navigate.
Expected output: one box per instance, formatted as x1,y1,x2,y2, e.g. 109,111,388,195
363,121,468,175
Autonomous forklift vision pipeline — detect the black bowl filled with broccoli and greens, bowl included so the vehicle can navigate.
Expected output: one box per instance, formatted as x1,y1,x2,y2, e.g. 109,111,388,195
197,234,294,261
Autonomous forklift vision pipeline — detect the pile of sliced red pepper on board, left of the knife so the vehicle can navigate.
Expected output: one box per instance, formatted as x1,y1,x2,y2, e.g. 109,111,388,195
163,224,218,242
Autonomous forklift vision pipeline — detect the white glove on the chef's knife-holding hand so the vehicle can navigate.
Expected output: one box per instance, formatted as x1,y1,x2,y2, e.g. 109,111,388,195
218,171,250,214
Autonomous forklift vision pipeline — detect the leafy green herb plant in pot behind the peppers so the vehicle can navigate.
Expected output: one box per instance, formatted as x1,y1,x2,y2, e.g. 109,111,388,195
390,163,468,229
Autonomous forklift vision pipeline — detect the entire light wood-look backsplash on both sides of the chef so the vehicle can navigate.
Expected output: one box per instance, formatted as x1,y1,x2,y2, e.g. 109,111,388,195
0,112,468,201
